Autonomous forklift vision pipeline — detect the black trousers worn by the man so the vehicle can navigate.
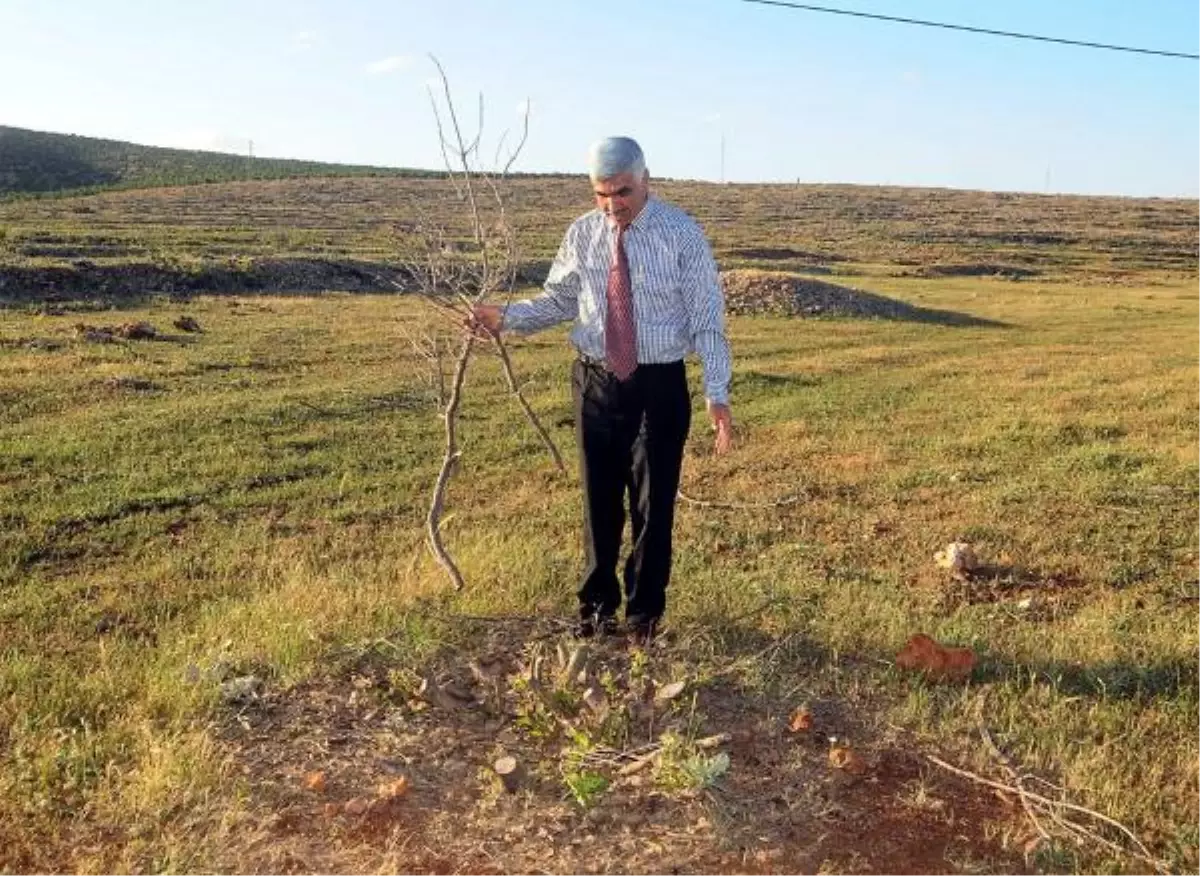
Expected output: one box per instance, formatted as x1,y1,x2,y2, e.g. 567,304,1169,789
571,359,691,623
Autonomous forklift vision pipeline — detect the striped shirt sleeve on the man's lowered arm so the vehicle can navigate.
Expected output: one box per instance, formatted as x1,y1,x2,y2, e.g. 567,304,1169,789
679,228,732,404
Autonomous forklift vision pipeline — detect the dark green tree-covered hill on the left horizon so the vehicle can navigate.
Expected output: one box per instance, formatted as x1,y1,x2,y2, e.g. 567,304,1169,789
0,125,430,198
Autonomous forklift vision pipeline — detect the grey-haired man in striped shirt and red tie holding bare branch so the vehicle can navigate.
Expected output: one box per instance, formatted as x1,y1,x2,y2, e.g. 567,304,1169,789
474,137,733,642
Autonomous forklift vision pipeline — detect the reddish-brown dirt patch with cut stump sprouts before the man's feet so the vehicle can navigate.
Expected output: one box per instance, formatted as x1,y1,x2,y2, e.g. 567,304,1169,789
216,619,1020,874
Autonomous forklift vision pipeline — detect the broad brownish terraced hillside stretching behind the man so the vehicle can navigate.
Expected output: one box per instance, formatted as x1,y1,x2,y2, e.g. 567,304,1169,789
0,176,1200,312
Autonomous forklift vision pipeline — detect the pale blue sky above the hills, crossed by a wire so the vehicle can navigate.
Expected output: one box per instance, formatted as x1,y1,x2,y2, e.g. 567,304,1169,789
0,0,1200,197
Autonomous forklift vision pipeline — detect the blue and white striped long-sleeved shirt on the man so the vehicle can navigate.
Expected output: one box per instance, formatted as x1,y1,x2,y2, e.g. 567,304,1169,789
504,197,731,404
